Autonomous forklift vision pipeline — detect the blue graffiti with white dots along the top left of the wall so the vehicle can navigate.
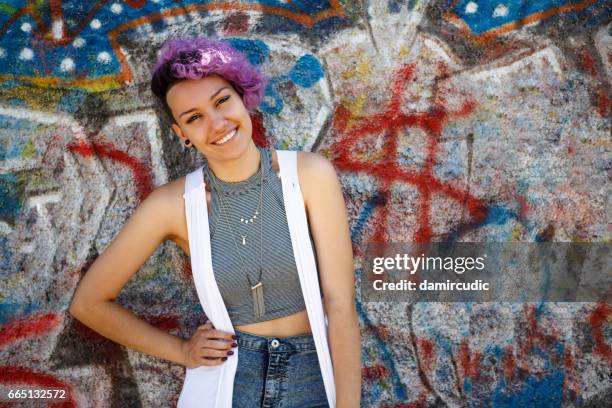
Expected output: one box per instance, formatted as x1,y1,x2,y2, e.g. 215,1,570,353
0,0,336,80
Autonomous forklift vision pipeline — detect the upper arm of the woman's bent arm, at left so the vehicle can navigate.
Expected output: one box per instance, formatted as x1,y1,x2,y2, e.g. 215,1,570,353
71,186,184,311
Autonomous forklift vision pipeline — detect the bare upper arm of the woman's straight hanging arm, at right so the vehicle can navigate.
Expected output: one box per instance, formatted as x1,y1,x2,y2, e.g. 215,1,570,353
298,153,355,313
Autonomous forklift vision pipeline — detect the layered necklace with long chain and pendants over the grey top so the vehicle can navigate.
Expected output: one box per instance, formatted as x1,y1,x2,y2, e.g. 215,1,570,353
207,153,266,319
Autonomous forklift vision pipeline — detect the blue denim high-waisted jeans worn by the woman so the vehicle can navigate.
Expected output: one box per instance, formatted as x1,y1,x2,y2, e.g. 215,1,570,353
232,330,329,408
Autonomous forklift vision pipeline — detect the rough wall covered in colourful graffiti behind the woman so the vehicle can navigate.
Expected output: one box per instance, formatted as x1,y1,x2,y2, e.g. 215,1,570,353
0,0,612,408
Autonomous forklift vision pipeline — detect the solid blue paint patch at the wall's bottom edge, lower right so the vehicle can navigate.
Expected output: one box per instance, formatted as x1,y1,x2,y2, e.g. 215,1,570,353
490,370,565,408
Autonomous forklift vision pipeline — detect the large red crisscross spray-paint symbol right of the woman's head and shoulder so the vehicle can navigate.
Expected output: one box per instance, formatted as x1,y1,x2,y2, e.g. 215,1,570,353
331,64,486,242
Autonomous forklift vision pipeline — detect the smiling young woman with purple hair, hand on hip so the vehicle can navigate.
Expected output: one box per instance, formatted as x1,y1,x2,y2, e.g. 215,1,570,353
70,39,361,408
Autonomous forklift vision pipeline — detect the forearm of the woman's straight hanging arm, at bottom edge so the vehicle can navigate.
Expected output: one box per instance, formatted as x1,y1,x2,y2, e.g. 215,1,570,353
328,307,361,408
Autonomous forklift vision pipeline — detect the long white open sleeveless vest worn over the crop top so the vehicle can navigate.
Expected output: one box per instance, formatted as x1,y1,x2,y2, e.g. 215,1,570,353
177,151,336,408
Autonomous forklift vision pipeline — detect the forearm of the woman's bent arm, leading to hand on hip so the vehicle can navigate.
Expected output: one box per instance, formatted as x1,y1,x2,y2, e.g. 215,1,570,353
70,301,185,365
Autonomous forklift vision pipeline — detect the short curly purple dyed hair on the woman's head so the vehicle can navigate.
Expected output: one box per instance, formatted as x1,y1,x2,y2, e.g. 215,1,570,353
151,38,267,121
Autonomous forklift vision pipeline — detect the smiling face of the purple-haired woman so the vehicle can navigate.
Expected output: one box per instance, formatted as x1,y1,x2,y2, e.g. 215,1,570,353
166,75,254,162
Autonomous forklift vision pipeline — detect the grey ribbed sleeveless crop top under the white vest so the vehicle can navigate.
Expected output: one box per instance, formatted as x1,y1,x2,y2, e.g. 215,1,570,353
204,149,314,325
